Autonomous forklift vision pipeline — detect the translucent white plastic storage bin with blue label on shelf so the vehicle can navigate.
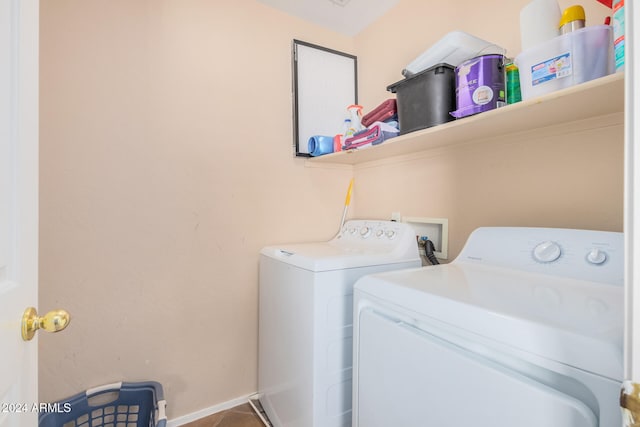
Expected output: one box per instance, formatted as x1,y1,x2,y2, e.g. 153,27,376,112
515,25,615,100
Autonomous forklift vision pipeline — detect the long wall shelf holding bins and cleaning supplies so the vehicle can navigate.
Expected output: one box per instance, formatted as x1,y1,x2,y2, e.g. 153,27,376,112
307,73,624,166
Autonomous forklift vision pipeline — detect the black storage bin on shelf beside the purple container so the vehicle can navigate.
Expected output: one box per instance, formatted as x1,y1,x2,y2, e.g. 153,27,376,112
387,64,456,135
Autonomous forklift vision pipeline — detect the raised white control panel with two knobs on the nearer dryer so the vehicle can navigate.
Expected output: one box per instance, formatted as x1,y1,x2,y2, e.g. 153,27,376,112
459,227,624,285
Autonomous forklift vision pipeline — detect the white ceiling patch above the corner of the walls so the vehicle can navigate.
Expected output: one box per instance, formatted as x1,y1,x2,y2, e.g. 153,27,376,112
258,0,399,36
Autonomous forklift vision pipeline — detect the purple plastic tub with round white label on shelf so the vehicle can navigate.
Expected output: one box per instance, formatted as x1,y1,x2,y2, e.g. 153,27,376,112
451,55,506,119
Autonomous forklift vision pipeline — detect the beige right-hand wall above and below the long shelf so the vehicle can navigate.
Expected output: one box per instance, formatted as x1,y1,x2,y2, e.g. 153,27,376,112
354,0,624,260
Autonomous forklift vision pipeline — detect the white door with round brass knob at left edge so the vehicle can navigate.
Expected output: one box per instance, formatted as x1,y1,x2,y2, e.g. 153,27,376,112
0,0,38,427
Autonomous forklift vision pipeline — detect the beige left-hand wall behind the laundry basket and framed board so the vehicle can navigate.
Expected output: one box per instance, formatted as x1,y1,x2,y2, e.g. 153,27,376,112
39,0,353,418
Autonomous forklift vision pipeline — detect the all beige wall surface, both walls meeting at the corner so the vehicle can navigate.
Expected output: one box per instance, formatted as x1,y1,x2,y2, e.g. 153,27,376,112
39,0,623,418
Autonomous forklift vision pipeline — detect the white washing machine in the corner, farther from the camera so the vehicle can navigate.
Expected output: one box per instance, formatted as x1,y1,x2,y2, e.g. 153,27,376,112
258,220,421,427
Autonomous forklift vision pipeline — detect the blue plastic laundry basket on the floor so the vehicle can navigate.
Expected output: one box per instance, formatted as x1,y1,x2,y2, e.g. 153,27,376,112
38,381,167,427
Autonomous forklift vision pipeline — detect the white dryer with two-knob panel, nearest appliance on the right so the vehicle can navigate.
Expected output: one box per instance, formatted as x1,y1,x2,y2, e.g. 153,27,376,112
353,228,624,427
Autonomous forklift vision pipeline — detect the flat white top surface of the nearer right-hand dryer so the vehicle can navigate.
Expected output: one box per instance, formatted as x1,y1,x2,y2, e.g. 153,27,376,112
356,263,624,380
